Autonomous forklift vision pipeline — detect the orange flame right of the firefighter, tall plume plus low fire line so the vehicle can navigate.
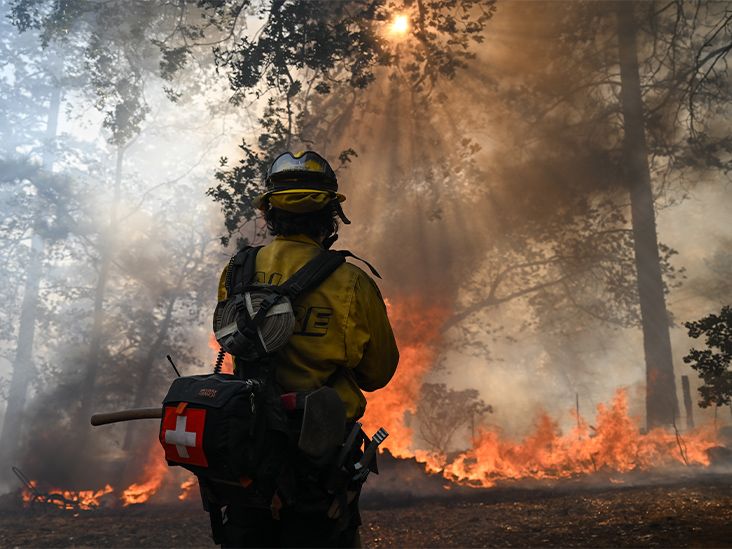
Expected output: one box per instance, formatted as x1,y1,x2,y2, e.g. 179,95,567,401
363,299,716,487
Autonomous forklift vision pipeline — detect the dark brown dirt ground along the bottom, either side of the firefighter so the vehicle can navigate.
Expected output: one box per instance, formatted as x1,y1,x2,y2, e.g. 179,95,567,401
0,475,732,548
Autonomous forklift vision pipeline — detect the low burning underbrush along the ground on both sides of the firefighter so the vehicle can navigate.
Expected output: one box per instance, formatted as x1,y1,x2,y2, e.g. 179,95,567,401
14,391,717,510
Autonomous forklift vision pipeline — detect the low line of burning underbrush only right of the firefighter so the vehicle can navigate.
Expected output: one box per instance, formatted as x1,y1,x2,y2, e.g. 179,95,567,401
360,390,718,499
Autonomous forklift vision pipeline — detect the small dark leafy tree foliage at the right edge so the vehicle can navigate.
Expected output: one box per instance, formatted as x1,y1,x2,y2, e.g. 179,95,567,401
684,305,732,408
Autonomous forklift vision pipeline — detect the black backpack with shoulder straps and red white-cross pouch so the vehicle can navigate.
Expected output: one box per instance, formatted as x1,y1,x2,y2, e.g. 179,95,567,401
159,247,351,504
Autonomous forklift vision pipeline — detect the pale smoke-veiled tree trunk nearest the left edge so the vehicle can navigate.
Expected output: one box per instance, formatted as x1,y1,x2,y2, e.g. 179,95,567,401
0,87,62,464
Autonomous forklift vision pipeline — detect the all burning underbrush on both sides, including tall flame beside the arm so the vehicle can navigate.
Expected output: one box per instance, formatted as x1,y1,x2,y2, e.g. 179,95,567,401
10,300,719,510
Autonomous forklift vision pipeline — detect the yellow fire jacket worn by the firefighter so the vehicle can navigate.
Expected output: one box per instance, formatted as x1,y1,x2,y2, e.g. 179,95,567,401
218,235,399,419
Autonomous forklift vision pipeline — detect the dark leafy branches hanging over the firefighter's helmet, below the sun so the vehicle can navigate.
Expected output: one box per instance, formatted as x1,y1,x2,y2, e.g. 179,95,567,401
204,0,495,244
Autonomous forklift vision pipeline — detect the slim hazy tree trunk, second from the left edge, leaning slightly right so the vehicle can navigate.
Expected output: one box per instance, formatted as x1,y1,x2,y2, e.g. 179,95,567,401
77,146,125,428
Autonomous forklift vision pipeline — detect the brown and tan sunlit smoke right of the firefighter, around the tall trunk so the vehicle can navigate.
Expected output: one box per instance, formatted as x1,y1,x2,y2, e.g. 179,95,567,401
329,3,730,436
